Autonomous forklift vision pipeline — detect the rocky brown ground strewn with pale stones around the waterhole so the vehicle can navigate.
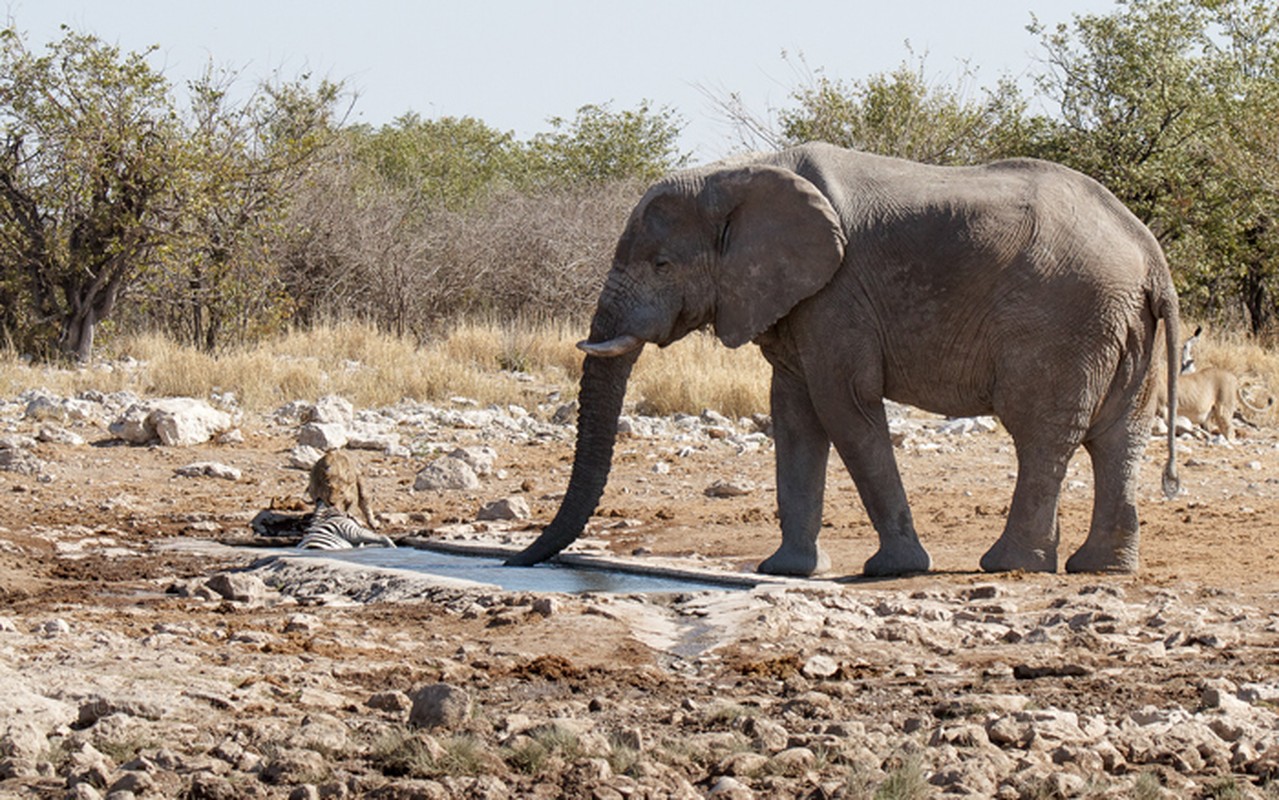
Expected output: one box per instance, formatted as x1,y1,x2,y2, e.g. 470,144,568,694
0,381,1279,799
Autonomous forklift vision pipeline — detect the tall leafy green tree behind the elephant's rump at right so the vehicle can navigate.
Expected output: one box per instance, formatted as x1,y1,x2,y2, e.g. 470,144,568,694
1031,0,1279,333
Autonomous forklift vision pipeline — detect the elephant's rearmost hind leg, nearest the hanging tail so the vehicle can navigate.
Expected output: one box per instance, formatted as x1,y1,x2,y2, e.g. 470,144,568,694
1065,415,1147,572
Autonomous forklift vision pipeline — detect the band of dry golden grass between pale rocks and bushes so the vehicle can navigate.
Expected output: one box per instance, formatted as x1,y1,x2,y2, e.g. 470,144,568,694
0,323,1279,422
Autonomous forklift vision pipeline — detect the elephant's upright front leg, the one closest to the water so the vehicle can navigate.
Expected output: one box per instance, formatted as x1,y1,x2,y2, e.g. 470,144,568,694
760,369,830,577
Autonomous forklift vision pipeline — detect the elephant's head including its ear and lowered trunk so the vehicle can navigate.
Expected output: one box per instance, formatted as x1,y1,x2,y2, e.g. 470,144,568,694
506,164,845,564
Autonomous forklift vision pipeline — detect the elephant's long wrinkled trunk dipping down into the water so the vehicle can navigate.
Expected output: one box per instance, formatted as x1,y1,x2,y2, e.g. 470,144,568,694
506,335,643,567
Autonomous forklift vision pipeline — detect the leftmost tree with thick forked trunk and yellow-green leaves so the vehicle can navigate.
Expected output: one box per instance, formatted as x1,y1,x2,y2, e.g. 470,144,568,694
0,28,179,360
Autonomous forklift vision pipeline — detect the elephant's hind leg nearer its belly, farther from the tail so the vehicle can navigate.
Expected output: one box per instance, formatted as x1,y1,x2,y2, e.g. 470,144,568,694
981,429,1078,572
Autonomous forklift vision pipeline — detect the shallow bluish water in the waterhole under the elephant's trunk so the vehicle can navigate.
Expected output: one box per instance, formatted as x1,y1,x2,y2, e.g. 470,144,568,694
292,548,741,594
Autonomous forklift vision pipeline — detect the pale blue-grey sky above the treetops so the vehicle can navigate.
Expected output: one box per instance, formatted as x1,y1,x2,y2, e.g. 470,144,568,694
0,0,1117,163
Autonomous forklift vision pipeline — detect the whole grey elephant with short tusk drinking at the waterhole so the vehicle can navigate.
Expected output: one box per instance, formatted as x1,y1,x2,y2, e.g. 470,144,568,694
506,138,1179,576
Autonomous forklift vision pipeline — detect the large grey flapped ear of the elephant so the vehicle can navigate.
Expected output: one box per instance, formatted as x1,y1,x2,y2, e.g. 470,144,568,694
706,165,845,347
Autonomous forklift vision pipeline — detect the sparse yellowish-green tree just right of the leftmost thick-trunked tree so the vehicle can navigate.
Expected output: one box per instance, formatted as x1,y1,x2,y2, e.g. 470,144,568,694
139,67,341,351
